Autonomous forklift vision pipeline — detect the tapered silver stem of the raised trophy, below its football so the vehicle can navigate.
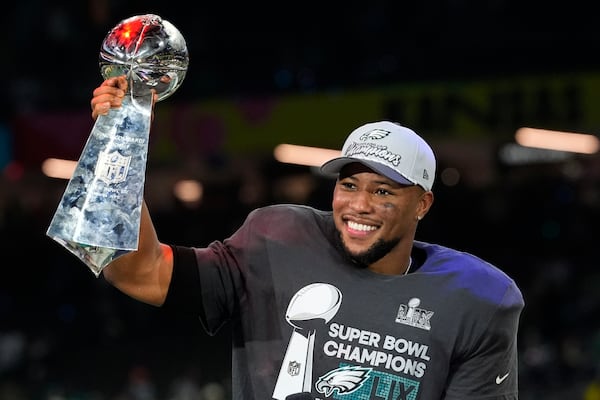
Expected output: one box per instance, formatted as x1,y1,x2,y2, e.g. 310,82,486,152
46,92,152,277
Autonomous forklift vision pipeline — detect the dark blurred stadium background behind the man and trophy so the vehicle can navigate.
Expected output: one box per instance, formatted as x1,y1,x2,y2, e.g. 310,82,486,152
0,0,600,400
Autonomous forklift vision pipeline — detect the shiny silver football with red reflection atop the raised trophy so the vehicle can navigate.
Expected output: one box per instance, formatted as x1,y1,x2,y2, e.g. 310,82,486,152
100,14,189,101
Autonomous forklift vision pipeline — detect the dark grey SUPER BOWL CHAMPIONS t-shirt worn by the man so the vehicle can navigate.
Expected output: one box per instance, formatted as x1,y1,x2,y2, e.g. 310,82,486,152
165,205,524,400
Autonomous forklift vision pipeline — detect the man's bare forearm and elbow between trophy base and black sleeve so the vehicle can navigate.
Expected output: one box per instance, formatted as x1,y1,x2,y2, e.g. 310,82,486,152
102,202,173,306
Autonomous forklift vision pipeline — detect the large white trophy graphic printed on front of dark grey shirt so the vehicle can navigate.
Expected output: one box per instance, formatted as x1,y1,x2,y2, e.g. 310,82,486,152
273,283,342,400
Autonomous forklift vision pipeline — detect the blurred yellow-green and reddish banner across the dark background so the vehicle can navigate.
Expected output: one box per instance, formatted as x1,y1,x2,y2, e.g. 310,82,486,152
14,74,600,166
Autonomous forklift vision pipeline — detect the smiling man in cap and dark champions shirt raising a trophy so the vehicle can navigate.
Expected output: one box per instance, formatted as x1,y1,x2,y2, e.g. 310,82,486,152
91,77,524,400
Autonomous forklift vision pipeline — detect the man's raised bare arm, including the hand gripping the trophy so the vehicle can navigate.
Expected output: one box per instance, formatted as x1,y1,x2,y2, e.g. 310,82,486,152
90,76,173,306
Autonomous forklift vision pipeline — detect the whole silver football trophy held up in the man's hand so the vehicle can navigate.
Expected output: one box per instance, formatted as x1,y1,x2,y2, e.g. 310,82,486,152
47,14,189,276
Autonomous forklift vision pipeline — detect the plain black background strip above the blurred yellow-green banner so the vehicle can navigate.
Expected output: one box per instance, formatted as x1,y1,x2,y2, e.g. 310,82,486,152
3,0,600,112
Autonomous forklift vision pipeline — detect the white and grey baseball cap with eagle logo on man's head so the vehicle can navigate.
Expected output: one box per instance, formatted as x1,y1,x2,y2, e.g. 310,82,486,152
321,121,436,190
